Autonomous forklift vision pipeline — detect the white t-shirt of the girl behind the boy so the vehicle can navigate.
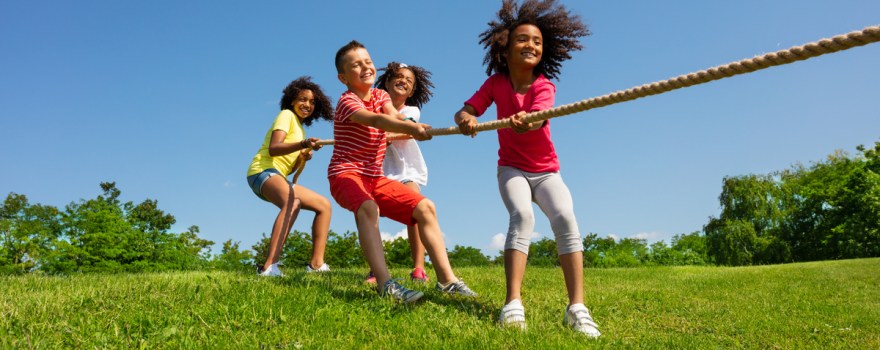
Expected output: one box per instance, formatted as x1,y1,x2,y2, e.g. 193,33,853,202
382,106,428,186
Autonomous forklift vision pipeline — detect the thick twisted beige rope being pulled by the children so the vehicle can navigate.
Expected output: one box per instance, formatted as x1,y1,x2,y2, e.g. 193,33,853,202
318,26,880,145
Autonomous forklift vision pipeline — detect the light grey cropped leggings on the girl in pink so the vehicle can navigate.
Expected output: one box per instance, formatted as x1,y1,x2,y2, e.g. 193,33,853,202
498,166,584,255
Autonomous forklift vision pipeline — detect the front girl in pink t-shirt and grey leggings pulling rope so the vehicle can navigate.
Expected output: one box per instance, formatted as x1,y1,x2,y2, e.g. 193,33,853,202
455,0,600,337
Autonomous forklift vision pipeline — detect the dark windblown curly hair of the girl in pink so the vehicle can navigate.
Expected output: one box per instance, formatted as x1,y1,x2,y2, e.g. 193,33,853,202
480,0,590,79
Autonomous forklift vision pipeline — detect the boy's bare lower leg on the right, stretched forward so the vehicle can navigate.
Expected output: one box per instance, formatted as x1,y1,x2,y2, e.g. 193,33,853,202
410,198,458,284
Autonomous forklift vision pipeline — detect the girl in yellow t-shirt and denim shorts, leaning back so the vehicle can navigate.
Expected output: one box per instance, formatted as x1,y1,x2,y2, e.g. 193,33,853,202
247,77,333,276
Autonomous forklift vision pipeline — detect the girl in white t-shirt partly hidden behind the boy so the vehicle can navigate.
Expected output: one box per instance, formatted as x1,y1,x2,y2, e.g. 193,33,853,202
367,62,434,283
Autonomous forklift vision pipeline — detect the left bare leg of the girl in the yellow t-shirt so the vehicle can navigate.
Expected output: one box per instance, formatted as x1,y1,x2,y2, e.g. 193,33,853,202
263,176,300,270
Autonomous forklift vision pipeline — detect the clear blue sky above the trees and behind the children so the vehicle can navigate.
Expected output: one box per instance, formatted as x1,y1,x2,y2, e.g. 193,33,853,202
0,0,880,255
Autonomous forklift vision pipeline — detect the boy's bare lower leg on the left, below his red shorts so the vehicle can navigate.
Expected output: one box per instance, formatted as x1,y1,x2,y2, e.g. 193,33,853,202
355,201,391,288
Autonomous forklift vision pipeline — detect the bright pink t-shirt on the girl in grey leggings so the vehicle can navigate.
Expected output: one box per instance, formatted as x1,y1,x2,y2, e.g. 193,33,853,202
465,73,559,173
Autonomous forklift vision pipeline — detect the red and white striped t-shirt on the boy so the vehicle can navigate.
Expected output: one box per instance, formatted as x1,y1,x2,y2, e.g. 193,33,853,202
327,89,391,177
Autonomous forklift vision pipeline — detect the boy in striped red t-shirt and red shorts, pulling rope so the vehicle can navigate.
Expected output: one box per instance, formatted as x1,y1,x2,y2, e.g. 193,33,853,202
327,41,476,303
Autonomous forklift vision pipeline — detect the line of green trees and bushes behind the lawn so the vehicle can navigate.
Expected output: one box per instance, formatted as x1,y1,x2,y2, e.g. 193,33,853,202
0,142,880,274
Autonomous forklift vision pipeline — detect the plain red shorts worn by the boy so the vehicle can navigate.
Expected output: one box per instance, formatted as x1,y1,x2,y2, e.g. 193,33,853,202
330,173,425,225
